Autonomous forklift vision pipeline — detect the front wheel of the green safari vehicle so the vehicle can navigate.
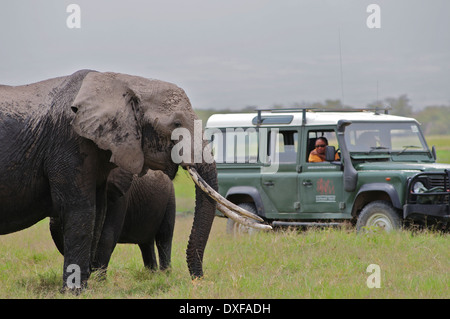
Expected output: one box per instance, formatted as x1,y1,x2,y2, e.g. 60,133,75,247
356,200,402,232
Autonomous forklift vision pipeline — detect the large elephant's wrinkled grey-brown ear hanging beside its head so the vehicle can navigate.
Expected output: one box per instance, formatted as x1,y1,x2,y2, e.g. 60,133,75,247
72,72,144,174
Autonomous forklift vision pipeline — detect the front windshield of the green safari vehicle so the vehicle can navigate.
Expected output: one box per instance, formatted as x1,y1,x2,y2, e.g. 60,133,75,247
345,122,428,154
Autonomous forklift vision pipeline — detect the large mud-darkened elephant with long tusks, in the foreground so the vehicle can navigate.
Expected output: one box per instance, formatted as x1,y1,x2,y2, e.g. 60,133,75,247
0,70,260,291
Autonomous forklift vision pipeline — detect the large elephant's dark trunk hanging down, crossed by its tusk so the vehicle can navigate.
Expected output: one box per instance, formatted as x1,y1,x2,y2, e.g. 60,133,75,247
186,163,218,278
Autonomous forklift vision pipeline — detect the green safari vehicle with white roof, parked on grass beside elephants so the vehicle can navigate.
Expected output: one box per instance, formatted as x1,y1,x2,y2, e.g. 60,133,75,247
206,109,450,232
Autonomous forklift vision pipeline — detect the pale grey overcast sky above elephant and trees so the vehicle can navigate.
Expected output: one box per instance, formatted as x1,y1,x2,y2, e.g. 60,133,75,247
0,0,450,109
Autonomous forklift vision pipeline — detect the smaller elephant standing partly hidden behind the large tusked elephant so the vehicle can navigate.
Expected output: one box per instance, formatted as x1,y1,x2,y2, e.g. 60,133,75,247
50,168,176,274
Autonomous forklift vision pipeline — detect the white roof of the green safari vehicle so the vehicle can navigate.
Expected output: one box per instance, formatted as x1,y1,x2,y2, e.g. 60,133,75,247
206,111,417,128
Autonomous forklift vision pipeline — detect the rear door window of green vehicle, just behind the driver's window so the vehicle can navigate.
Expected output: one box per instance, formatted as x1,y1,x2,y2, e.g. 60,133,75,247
267,131,298,164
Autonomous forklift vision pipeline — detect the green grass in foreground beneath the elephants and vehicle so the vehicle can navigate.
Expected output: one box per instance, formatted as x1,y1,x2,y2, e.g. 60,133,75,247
0,215,450,299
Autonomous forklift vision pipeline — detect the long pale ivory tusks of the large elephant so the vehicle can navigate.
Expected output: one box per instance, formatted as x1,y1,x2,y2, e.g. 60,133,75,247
186,166,272,230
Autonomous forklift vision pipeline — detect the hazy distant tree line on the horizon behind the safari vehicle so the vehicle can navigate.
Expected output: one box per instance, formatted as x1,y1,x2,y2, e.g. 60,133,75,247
196,94,450,135
